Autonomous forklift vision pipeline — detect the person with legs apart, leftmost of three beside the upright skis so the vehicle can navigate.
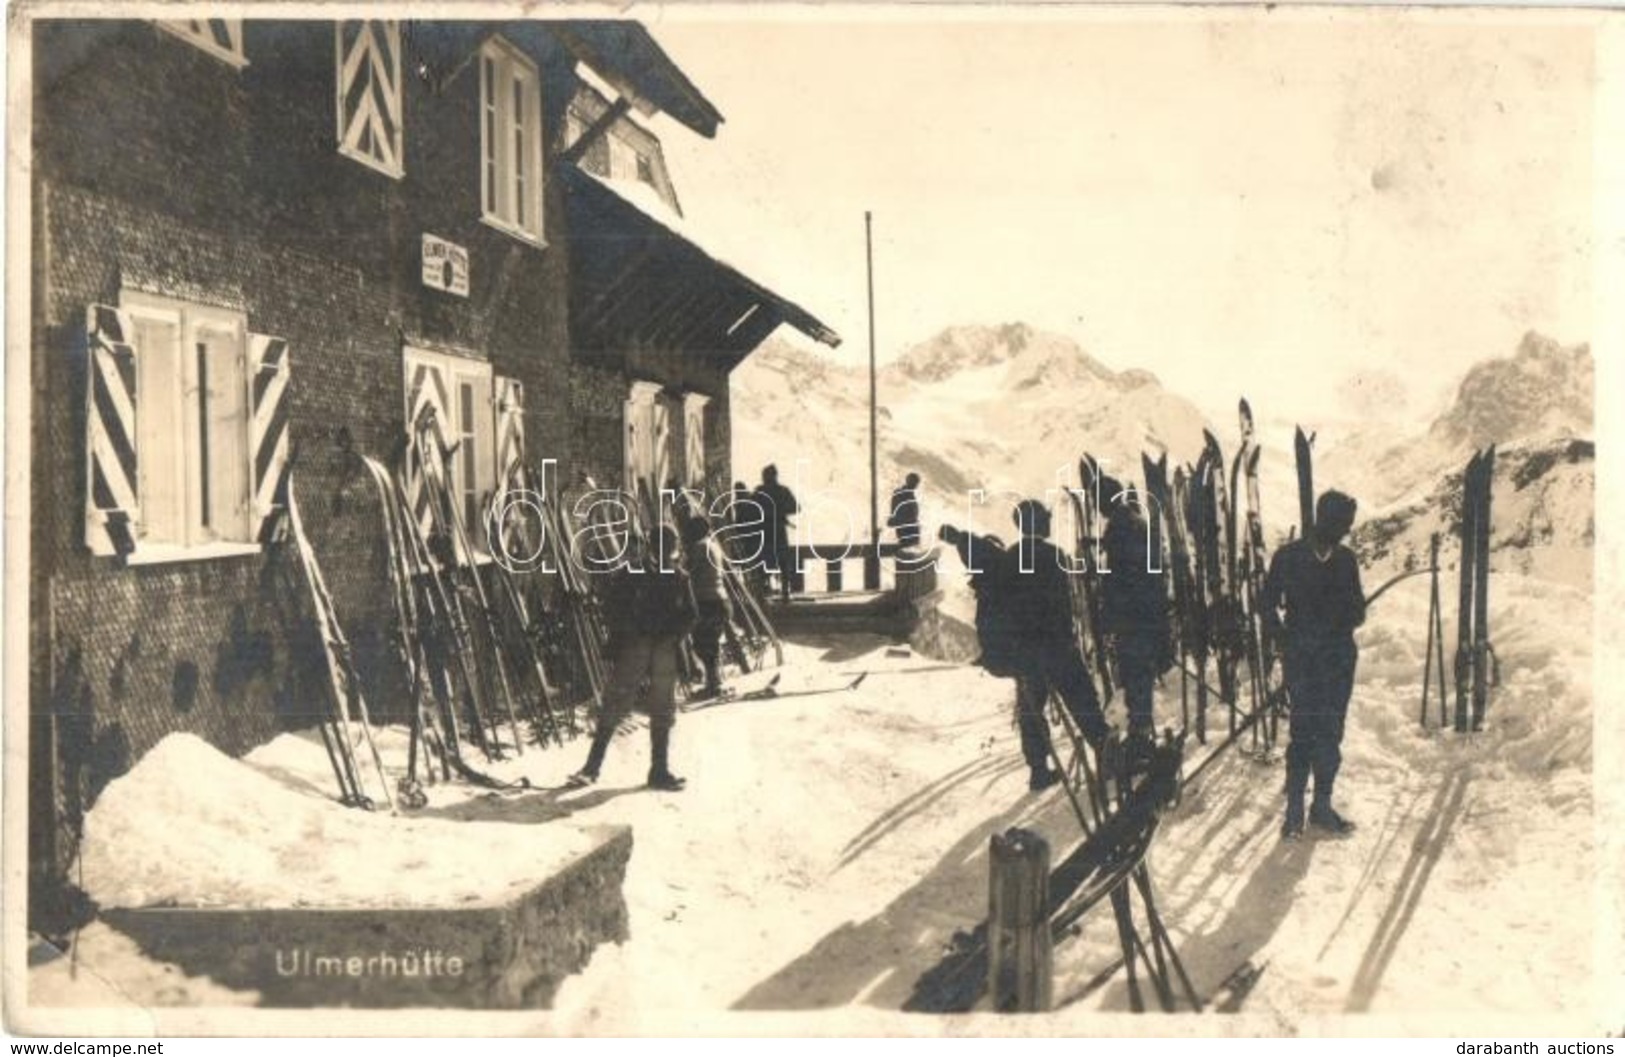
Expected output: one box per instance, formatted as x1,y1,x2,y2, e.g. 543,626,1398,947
1006,499,1107,790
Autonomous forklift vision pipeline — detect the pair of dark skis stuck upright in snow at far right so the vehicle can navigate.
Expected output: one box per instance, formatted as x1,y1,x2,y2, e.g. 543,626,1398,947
1456,444,1497,733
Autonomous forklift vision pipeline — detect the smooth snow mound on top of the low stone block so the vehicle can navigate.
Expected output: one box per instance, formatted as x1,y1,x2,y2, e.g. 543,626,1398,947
81,733,588,907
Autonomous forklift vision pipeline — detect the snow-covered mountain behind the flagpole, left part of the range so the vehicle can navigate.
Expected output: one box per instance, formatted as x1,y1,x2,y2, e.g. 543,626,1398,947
733,324,1206,538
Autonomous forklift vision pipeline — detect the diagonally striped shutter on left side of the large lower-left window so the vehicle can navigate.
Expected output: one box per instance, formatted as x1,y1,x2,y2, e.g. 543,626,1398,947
85,304,141,555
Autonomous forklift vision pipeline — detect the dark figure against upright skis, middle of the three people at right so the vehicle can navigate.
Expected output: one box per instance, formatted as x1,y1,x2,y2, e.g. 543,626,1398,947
1100,491,1173,737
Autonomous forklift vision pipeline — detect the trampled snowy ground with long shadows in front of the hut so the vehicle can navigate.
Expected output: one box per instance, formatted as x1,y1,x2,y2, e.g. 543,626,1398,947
31,576,1619,1033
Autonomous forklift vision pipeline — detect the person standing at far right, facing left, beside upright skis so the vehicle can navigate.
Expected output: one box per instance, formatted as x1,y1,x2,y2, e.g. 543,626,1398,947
1259,491,1365,841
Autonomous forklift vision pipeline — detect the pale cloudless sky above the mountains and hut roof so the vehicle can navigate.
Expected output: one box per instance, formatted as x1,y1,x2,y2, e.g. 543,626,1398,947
644,10,1593,420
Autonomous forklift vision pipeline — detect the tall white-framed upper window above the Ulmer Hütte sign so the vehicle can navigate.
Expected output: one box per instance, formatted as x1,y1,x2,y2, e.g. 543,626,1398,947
479,37,541,242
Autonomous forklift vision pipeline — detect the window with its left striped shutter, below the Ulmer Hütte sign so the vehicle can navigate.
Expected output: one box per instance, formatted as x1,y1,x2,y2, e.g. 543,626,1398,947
405,346,497,545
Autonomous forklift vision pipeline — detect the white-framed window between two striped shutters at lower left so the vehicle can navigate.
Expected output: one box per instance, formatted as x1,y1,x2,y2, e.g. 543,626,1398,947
122,294,252,550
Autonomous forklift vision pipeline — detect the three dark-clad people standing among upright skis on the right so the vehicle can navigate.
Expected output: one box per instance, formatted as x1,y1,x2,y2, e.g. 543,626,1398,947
941,489,1365,841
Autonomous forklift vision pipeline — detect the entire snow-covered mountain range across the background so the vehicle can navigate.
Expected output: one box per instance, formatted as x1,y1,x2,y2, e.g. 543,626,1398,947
733,324,1594,585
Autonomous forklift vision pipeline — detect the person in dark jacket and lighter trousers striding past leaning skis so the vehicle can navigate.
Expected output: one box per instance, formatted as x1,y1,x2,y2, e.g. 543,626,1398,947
569,525,696,792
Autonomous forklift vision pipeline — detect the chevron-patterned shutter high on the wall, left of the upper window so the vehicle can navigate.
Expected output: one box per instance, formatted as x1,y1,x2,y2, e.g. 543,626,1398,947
333,21,405,177
